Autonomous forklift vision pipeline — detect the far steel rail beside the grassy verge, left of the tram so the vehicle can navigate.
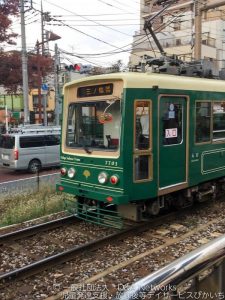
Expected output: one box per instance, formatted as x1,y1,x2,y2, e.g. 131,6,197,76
0,215,78,245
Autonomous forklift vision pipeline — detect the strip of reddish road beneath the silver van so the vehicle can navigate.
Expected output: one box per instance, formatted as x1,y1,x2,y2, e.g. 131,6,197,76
0,167,59,183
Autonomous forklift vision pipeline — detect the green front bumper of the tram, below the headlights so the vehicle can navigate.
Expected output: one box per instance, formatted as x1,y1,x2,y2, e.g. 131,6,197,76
56,183,129,205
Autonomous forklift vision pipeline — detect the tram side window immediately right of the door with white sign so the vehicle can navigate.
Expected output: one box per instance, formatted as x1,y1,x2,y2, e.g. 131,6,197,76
195,101,211,143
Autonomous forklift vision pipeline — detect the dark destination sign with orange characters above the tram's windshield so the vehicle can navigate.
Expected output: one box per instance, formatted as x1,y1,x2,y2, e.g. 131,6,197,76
77,83,113,98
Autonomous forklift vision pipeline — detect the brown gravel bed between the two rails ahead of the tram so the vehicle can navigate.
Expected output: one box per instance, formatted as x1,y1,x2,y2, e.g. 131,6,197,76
0,221,115,275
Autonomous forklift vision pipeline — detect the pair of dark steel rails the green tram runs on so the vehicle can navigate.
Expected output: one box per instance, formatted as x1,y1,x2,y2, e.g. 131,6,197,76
0,212,179,284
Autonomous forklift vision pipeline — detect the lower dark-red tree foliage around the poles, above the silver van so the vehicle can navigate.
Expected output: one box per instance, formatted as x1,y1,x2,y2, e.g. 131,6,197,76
0,50,53,94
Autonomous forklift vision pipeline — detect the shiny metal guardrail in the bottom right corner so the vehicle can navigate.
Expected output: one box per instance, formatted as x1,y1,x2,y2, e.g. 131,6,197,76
114,235,225,300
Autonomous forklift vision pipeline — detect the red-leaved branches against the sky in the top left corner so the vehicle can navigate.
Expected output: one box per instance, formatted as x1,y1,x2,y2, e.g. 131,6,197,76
0,0,19,44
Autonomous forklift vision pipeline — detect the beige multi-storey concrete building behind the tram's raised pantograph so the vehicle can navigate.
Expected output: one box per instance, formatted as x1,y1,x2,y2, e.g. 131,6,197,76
129,0,225,75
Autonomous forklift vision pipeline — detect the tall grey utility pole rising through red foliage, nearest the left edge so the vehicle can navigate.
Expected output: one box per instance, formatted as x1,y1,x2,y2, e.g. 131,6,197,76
20,0,30,124
